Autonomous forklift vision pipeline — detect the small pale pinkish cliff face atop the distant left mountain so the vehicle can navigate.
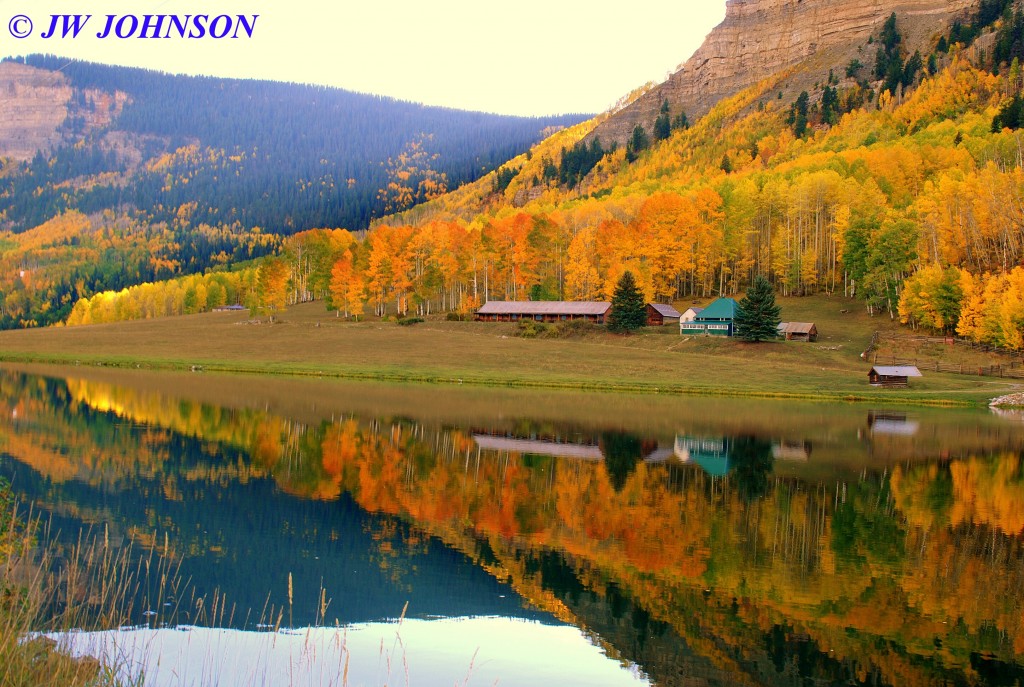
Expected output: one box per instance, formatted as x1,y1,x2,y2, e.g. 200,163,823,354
0,62,127,160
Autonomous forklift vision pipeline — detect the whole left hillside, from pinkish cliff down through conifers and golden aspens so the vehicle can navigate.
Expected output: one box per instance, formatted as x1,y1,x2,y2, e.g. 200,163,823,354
0,55,583,328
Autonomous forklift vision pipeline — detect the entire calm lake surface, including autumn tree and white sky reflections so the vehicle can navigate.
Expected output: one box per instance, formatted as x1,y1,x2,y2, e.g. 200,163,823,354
6,367,1024,686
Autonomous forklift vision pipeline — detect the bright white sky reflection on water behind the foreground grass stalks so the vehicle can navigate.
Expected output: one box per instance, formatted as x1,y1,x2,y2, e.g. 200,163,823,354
57,617,647,687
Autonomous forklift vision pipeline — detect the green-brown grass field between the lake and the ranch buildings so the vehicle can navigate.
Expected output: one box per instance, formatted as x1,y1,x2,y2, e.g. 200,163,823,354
0,297,1018,404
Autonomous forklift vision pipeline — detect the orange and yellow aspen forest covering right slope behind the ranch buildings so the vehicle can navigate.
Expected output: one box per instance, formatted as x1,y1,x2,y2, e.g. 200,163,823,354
18,5,1024,350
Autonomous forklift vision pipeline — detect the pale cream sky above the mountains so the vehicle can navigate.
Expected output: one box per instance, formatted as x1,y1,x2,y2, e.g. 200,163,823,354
0,0,725,115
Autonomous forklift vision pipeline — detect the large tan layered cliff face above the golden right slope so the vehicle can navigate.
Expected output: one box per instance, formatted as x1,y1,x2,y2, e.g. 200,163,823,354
595,0,977,142
